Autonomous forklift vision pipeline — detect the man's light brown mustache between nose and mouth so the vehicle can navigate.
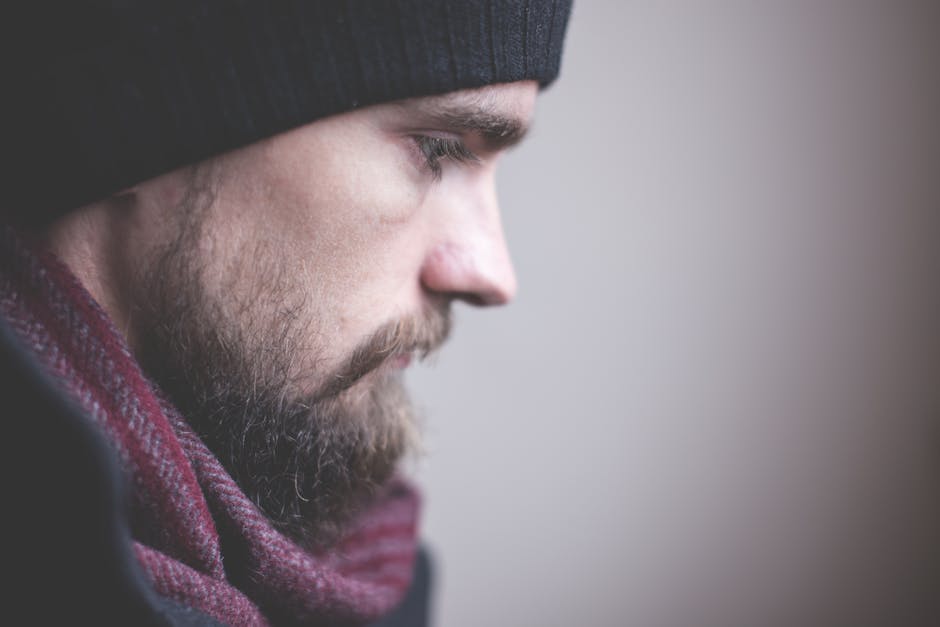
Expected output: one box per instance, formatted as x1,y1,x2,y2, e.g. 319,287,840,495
316,303,453,401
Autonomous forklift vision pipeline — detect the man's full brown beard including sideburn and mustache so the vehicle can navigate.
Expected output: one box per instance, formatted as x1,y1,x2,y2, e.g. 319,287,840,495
134,175,450,549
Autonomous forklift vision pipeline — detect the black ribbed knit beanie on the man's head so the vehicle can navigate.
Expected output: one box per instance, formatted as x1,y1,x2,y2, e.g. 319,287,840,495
0,0,571,219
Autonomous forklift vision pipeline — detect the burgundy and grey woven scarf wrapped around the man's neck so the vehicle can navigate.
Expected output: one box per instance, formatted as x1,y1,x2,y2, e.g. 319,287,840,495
0,228,418,625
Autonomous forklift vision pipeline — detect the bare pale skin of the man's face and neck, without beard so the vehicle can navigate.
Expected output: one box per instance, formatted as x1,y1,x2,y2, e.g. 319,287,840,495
45,81,537,392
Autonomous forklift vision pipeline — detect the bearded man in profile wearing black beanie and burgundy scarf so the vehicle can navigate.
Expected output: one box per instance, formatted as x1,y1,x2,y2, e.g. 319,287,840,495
0,0,569,625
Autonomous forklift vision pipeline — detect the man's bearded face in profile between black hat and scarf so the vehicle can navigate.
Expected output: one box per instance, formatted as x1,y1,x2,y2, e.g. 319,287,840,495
110,81,537,546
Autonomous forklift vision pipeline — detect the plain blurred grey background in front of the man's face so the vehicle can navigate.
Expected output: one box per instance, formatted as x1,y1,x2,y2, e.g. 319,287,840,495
411,0,940,627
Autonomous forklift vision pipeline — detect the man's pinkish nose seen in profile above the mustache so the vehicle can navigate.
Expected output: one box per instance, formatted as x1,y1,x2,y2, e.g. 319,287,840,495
421,190,517,306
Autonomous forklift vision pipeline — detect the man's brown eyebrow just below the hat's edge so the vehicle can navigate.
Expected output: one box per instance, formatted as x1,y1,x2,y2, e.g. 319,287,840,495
404,95,529,151
